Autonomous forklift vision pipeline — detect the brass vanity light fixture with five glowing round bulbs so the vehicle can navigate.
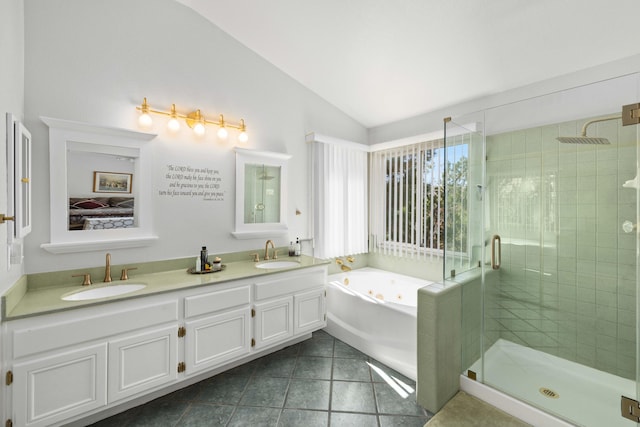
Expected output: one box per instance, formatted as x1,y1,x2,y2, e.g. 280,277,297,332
136,98,249,143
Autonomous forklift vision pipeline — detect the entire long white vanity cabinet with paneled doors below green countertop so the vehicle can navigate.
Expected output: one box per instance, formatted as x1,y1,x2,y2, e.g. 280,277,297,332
2,265,327,427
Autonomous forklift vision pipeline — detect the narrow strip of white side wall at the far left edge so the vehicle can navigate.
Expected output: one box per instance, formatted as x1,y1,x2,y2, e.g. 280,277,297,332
0,0,24,292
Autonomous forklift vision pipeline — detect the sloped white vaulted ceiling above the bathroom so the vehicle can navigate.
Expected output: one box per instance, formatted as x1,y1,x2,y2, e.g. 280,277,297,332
178,0,640,128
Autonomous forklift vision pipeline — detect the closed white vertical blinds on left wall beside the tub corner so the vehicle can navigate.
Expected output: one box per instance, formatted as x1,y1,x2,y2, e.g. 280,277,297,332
311,135,368,258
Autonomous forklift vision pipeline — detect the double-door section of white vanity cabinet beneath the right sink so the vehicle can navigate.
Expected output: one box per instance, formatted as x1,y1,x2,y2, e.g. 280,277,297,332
254,267,327,349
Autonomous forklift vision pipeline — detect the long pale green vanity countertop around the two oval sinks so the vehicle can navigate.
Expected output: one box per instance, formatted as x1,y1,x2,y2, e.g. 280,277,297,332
2,255,329,321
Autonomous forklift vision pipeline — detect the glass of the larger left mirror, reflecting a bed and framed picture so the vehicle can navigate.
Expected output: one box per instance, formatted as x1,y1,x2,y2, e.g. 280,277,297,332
67,150,136,231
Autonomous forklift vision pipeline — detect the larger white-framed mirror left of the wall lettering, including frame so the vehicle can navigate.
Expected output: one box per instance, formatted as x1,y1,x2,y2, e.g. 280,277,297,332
41,117,157,253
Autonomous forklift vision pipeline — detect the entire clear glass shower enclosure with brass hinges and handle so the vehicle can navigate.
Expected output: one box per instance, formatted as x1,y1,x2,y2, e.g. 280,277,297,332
444,75,640,427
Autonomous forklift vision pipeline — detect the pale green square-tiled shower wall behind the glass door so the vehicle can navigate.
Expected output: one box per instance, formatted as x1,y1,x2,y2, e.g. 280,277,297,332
485,115,637,378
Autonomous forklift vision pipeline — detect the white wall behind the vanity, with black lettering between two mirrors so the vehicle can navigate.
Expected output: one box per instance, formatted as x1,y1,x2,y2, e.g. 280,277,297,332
25,0,367,273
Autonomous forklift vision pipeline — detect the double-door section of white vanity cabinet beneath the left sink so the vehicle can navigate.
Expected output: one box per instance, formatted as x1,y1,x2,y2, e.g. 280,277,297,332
5,297,178,427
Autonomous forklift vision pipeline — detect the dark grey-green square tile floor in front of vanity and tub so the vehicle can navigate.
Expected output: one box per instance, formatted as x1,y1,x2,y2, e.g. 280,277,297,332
94,331,433,427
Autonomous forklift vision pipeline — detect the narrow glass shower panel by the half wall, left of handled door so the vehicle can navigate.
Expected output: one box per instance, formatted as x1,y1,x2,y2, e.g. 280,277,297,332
443,113,487,374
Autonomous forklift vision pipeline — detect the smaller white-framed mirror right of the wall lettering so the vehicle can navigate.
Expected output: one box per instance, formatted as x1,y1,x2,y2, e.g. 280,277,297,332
233,147,291,239
